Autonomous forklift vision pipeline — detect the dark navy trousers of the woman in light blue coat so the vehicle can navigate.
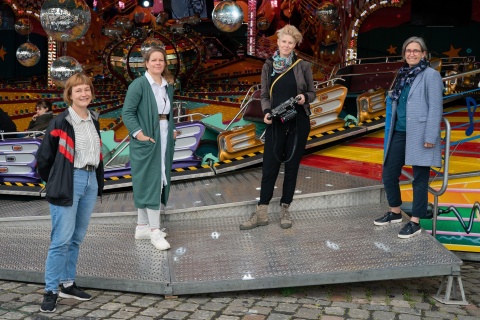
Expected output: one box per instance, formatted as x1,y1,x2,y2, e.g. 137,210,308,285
382,131,430,218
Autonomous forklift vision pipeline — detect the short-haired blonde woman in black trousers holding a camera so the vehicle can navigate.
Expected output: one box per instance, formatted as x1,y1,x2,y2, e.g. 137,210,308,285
240,25,315,230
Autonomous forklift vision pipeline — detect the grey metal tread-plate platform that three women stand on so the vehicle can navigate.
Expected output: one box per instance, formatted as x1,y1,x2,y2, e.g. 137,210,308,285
0,167,462,295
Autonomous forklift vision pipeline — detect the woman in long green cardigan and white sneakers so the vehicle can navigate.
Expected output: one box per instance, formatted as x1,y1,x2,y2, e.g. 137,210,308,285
123,47,176,250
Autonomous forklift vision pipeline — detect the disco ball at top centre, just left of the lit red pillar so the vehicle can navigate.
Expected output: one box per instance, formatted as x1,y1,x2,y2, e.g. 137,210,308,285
212,0,243,32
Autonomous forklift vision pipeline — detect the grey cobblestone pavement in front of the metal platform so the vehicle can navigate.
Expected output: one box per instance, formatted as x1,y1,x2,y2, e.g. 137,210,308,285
0,262,480,320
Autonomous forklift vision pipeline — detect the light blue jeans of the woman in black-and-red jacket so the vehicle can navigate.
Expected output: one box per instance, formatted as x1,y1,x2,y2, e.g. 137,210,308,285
45,169,98,293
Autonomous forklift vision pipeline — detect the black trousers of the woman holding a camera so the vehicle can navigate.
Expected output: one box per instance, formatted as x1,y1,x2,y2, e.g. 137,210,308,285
258,110,310,204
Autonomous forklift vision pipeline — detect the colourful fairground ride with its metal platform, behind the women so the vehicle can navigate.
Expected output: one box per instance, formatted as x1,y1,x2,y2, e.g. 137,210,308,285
0,0,480,303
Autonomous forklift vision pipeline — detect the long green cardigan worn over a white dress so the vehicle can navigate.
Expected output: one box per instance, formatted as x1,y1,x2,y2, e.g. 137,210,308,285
122,76,174,210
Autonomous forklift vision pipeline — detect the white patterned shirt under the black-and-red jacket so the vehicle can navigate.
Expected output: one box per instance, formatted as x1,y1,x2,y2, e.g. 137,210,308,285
68,107,100,168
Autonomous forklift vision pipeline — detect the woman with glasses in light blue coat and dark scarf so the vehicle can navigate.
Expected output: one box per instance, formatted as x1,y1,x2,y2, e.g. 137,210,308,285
374,37,443,239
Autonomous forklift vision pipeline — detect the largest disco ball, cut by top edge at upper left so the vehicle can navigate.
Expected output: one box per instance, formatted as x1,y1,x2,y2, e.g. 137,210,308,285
40,0,91,42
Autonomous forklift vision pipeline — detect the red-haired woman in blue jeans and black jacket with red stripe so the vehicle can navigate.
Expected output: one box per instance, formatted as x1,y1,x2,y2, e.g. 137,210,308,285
37,74,103,312
